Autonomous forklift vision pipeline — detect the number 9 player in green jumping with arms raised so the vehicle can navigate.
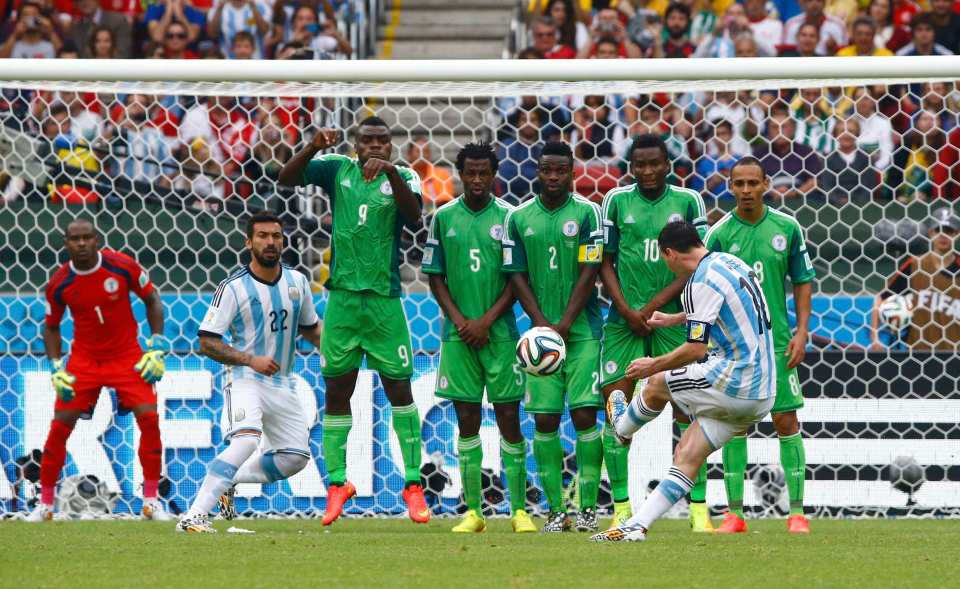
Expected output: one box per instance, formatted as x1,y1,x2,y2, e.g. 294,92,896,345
280,117,430,526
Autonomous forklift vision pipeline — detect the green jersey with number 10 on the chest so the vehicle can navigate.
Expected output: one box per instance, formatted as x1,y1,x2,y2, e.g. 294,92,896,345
602,184,707,321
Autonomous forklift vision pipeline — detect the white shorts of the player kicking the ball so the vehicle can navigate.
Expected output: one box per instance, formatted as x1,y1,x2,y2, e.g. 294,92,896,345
664,363,776,449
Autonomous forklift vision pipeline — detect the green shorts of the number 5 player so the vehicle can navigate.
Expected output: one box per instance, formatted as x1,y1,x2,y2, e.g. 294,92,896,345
437,341,525,403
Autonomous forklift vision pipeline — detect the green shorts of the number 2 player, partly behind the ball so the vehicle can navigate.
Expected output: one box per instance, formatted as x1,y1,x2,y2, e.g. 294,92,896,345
523,340,603,414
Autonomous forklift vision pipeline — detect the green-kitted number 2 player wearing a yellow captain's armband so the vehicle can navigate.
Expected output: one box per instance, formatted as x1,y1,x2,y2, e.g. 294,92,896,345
503,142,603,532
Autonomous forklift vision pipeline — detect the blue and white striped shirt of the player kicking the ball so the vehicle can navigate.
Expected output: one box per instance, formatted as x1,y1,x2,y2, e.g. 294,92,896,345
683,253,777,400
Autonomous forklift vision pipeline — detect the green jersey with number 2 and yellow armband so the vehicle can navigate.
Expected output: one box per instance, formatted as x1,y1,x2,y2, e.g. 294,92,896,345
503,193,603,342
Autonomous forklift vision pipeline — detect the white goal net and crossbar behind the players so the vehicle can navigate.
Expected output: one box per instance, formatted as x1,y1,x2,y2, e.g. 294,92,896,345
0,58,960,516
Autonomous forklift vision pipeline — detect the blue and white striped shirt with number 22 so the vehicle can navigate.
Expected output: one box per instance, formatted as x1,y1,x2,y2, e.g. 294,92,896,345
200,266,319,387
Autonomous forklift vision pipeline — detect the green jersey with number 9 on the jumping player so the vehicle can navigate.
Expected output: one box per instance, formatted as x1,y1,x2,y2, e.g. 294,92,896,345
303,154,420,297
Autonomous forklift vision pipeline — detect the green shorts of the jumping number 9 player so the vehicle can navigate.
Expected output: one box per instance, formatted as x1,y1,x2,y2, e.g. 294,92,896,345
320,290,413,380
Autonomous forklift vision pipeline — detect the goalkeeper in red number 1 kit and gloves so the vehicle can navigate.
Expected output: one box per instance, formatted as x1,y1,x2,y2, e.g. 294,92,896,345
28,219,170,521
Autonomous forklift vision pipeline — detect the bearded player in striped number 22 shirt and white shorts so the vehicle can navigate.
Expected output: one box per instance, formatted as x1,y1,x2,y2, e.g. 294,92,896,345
177,212,321,533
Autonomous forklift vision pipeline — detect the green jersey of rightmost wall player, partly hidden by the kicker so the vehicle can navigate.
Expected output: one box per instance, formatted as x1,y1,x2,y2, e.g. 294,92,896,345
705,207,817,353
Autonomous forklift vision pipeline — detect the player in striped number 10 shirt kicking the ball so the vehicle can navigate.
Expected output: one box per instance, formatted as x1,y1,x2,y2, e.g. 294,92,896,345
591,221,777,542
